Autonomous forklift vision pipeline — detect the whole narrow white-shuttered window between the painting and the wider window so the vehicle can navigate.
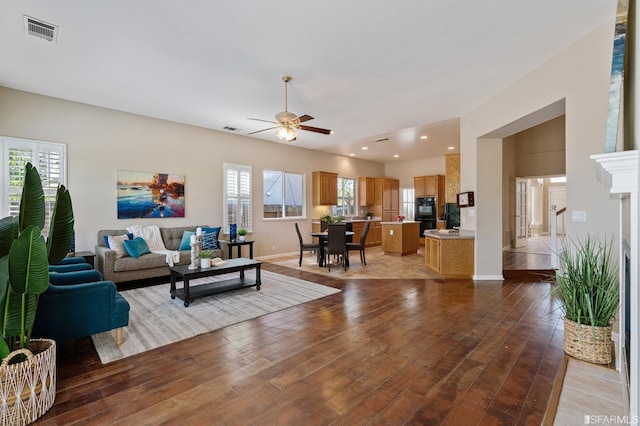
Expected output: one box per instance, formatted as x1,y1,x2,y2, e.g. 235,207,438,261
223,163,253,234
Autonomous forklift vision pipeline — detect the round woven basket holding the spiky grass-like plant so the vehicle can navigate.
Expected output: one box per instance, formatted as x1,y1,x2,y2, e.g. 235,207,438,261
564,318,611,364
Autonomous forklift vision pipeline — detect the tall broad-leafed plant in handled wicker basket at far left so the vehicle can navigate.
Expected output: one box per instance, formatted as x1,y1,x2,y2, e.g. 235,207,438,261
0,163,74,424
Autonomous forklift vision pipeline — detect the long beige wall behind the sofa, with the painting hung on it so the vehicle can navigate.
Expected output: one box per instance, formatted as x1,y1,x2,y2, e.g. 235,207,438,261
0,87,385,256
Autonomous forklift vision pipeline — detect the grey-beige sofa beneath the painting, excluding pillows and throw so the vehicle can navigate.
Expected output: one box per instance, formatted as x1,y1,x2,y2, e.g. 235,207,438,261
95,226,224,283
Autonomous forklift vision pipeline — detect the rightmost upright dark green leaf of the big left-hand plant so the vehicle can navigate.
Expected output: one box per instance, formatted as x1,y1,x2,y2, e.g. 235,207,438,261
47,185,74,265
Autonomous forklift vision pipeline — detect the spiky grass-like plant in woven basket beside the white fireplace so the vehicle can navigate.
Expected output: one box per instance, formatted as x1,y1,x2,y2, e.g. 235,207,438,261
552,235,620,364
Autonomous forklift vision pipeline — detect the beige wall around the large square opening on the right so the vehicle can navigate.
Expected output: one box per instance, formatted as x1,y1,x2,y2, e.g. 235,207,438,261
460,19,619,279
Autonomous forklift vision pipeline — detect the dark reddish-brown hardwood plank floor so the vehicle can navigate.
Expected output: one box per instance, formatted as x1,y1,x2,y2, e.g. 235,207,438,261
38,263,563,425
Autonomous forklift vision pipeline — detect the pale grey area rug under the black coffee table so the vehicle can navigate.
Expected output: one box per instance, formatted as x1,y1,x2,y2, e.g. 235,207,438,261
91,270,340,364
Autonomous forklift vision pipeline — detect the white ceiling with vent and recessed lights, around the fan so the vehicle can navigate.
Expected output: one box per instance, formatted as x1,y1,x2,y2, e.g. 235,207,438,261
0,0,616,162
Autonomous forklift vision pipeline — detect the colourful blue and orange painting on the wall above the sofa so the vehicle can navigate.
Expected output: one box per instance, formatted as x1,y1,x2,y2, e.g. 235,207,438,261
117,170,184,219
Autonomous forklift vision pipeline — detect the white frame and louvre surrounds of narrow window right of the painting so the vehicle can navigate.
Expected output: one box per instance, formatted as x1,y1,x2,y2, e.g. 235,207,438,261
222,163,253,234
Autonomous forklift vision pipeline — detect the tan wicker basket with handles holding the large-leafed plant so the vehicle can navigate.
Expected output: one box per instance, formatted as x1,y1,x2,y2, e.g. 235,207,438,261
0,339,56,425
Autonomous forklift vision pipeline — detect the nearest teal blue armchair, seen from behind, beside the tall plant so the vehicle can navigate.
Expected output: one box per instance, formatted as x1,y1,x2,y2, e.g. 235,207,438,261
32,269,129,346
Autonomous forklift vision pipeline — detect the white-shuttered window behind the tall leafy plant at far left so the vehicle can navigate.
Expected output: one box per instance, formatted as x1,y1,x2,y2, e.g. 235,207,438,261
2,137,66,235
